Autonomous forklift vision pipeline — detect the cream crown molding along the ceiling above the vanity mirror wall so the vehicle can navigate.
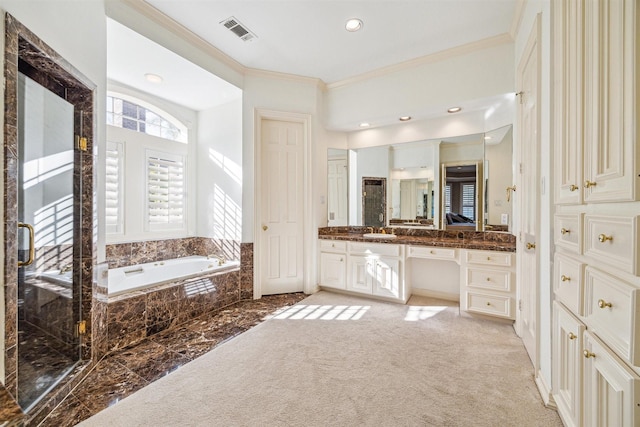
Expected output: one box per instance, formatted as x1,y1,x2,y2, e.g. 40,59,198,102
326,33,514,89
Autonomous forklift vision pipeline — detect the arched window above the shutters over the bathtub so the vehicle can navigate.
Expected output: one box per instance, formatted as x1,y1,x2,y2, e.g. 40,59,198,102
107,93,188,143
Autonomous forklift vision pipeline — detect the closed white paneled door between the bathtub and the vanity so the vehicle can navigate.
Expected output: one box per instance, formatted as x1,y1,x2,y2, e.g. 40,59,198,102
259,119,304,295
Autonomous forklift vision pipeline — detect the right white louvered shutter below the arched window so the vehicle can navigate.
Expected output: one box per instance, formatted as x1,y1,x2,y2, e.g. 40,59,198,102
147,152,185,228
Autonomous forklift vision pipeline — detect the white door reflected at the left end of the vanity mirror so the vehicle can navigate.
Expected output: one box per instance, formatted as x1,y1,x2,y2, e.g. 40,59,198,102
327,148,349,227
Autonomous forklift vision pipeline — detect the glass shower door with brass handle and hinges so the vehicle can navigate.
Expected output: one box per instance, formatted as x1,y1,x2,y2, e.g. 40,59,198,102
17,74,80,411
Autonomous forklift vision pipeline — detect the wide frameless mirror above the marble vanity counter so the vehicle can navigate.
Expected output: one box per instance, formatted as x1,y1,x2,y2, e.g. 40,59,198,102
328,125,514,232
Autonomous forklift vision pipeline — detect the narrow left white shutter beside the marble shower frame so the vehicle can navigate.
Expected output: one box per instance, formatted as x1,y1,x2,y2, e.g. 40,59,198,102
105,141,124,233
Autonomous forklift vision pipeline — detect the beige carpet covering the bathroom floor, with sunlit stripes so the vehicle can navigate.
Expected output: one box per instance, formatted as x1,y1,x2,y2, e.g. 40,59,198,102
80,292,562,427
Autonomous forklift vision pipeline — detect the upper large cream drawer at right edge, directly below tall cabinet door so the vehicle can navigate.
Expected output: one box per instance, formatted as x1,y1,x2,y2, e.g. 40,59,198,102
584,215,640,275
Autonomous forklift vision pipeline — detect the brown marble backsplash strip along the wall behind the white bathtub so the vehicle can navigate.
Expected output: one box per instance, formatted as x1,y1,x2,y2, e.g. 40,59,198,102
106,237,241,268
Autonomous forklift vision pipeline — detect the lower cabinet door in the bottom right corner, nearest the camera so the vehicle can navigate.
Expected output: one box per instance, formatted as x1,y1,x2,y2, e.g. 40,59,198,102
584,331,640,427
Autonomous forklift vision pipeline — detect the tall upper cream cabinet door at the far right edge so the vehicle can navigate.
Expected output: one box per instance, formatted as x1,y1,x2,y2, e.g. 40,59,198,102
583,0,640,202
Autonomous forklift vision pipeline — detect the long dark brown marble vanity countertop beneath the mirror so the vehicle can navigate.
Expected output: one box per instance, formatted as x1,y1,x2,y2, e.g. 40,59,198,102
318,226,516,252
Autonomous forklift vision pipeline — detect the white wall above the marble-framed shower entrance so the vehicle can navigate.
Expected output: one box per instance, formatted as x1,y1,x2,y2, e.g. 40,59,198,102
0,0,106,388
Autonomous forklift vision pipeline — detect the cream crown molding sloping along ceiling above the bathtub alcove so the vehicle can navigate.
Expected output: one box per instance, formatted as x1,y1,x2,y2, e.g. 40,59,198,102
114,0,247,74
